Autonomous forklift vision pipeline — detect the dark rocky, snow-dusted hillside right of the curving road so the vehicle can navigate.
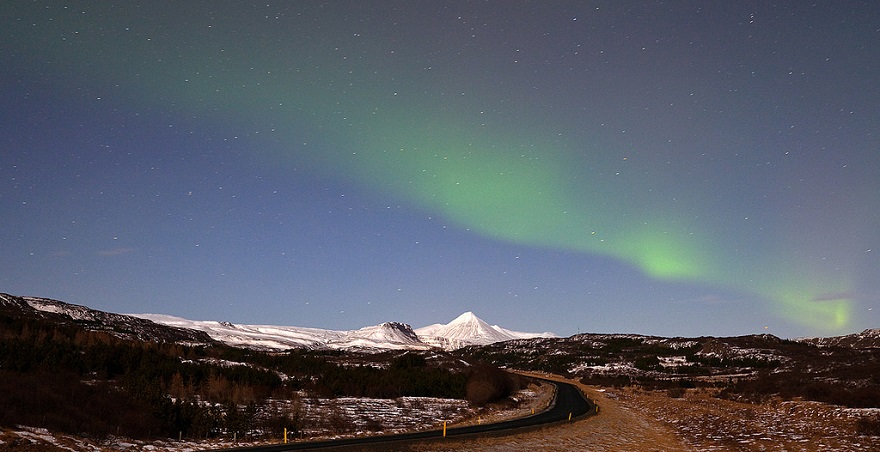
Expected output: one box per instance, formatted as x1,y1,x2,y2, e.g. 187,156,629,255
456,333,880,408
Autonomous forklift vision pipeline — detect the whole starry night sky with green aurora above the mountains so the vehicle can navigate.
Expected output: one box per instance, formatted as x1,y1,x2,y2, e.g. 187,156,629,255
0,1,880,337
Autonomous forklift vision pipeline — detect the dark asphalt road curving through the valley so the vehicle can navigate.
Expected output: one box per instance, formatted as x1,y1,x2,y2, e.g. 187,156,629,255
223,380,596,452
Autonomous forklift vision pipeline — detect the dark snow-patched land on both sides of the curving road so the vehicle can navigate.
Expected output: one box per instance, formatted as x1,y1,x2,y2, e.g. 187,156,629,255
0,294,880,450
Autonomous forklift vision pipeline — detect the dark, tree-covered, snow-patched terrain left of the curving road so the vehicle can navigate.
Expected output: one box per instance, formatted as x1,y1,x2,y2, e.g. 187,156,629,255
0,294,534,441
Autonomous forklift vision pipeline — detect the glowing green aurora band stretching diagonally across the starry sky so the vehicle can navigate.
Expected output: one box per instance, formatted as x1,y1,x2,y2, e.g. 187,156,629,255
5,1,868,331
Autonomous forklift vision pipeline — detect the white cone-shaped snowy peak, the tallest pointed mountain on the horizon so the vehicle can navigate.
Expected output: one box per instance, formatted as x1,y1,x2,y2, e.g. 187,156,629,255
415,311,556,350
